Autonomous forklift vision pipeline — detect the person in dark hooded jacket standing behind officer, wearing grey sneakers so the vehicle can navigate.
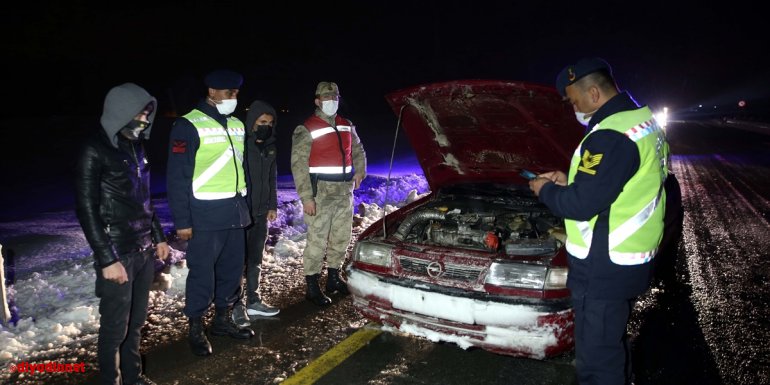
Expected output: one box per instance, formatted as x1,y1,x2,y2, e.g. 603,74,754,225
232,100,280,326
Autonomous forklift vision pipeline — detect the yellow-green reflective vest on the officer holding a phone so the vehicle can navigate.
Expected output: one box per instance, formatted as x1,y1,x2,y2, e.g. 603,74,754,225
564,107,669,265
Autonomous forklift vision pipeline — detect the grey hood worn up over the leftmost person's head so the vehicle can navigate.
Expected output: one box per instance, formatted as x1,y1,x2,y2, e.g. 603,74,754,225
100,83,158,148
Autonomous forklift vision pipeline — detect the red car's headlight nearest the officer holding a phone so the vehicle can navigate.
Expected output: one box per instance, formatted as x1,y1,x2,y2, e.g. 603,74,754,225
486,262,567,290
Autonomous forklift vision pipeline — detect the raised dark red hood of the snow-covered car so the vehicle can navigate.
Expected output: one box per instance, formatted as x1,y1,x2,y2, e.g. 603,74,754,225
385,80,584,191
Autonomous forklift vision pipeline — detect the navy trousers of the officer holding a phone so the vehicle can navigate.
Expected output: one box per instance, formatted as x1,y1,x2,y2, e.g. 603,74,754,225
572,297,634,385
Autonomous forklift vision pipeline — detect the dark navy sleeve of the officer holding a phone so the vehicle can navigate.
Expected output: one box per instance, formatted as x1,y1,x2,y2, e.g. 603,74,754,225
540,129,639,221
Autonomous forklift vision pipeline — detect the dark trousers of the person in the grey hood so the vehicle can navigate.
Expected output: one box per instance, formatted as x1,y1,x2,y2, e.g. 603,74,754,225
96,249,155,384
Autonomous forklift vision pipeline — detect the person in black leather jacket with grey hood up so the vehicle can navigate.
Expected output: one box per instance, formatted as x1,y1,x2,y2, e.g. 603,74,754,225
75,83,170,384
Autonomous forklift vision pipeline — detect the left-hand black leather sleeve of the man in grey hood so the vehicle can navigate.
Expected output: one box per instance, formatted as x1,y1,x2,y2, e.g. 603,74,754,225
75,144,118,268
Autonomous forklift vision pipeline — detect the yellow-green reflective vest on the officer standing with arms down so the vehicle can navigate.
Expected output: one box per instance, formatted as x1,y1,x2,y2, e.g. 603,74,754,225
184,110,246,200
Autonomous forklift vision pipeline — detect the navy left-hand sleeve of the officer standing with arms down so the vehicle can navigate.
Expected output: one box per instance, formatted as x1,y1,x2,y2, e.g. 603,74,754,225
166,118,200,229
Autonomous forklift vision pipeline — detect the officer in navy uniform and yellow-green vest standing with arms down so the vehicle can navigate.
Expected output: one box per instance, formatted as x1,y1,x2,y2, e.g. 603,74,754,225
166,70,254,356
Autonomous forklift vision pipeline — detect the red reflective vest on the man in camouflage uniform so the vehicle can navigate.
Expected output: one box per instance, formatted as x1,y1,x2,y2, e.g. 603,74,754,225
304,115,353,176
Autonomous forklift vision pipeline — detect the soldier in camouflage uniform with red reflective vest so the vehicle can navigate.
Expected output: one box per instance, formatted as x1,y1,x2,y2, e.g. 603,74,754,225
291,82,366,306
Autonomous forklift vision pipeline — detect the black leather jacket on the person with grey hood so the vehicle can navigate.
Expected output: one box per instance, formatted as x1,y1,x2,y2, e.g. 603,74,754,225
75,130,166,268
